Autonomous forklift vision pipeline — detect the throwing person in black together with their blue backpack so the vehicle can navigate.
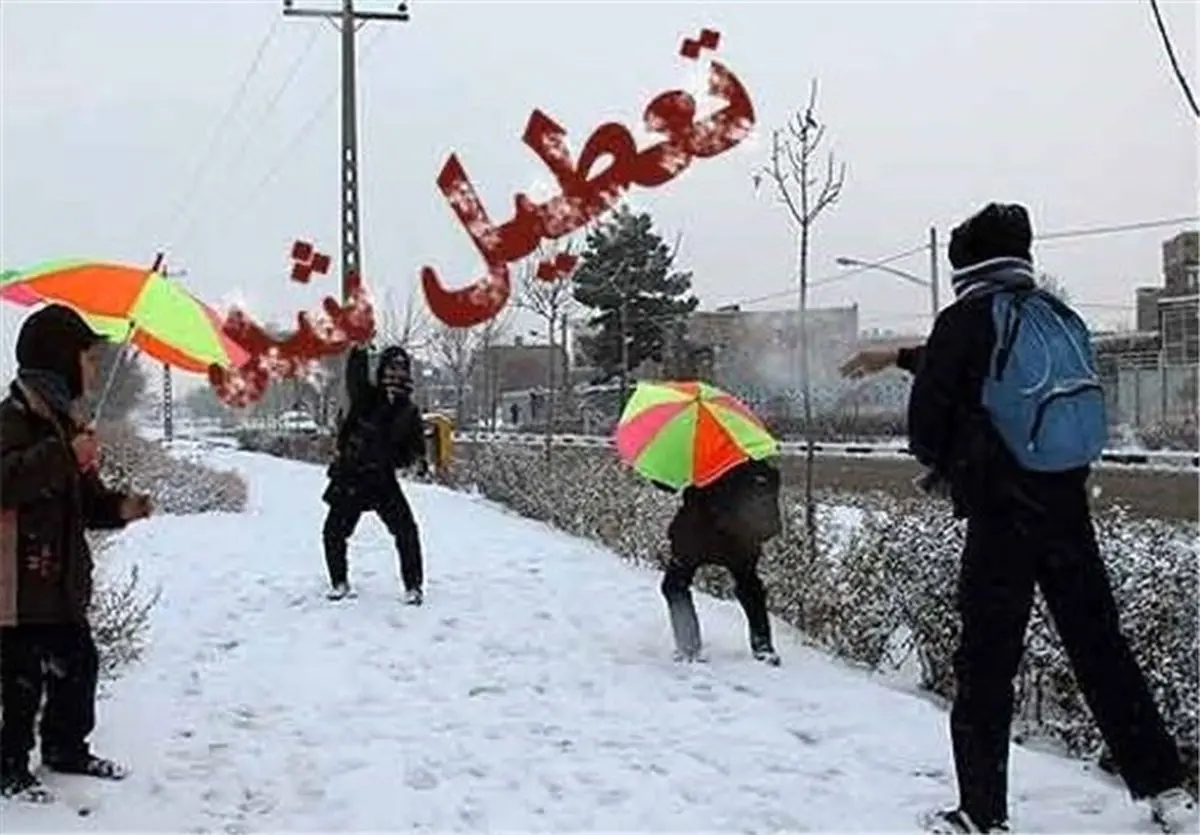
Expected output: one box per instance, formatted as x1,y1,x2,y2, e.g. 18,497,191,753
842,203,1196,833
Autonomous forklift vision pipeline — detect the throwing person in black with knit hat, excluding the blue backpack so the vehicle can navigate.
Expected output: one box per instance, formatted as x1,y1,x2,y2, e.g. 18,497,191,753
842,204,1195,833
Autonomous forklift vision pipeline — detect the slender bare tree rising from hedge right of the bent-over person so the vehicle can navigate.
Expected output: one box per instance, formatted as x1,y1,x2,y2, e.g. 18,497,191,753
754,79,846,555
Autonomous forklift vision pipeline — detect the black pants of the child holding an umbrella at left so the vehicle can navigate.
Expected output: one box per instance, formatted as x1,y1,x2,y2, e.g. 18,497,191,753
0,624,100,770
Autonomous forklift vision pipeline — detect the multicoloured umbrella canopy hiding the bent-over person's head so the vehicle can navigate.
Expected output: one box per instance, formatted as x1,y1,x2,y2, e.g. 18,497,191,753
617,382,779,489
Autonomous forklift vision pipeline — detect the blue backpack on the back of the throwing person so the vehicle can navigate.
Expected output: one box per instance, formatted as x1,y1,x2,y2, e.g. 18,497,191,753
983,289,1108,473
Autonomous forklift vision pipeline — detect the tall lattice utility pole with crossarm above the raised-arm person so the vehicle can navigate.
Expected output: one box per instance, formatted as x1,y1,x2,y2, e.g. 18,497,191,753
283,0,408,301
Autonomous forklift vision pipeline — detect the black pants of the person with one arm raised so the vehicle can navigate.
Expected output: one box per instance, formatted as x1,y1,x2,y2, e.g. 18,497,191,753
323,479,424,590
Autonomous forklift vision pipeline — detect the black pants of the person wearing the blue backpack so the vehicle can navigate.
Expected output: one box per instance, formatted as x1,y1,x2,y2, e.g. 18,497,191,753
950,487,1183,825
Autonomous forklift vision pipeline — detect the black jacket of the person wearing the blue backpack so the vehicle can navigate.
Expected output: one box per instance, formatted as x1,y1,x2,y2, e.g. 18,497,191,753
896,263,1088,517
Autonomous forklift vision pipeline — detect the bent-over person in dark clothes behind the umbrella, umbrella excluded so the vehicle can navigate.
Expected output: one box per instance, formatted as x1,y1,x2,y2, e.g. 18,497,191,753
652,461,782,666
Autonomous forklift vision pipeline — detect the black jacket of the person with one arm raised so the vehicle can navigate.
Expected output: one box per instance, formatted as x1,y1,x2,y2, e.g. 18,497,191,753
330,348,425,482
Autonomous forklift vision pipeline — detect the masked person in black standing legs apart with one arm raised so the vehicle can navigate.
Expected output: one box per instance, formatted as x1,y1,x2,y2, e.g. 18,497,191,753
323,346,428,606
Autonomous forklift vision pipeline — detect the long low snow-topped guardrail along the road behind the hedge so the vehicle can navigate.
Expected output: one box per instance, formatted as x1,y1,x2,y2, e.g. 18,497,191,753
454,432,1200,470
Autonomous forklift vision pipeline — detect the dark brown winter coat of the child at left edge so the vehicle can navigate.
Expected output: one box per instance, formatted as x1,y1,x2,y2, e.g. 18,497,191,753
0,383,125,626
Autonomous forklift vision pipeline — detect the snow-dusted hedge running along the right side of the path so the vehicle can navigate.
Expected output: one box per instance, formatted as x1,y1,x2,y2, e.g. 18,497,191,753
456,446,1200,773
